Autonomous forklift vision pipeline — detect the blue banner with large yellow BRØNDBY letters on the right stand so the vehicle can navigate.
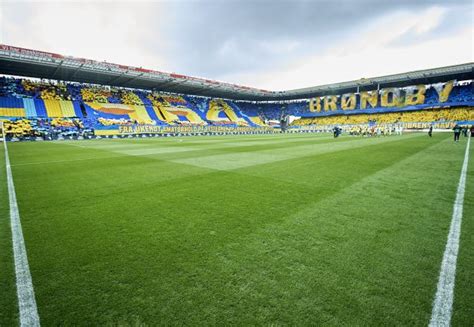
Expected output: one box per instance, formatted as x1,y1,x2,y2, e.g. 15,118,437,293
302,80,474,117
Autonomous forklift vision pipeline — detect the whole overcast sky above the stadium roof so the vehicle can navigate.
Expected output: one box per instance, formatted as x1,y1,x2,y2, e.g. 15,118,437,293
0,0,474,90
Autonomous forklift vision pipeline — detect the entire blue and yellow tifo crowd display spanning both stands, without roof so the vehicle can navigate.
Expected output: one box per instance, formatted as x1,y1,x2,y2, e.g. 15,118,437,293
0,77,474,139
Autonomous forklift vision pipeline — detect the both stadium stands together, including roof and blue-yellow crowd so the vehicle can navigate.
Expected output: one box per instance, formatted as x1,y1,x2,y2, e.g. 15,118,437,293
0,45,474,139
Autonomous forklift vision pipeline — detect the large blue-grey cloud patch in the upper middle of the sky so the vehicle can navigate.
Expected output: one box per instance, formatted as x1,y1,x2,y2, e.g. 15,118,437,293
144,0,469,78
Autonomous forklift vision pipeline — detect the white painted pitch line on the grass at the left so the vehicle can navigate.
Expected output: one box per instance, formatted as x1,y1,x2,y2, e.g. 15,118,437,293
3,141,40,326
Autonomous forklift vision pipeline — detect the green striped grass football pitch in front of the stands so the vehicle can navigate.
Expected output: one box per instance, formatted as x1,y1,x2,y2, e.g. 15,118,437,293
0,133,474,326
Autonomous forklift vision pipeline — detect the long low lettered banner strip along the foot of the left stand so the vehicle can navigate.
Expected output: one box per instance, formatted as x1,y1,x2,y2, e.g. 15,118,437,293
94,125,274,135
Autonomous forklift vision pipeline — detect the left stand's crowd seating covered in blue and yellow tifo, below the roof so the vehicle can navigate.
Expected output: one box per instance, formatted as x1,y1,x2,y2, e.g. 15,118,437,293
0,77,286,139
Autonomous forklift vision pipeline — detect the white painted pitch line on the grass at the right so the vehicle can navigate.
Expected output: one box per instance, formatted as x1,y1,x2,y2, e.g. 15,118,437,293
429,137,471,327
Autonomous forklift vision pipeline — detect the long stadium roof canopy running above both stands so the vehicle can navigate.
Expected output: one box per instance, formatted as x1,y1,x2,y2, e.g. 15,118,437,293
0,44,474,101
